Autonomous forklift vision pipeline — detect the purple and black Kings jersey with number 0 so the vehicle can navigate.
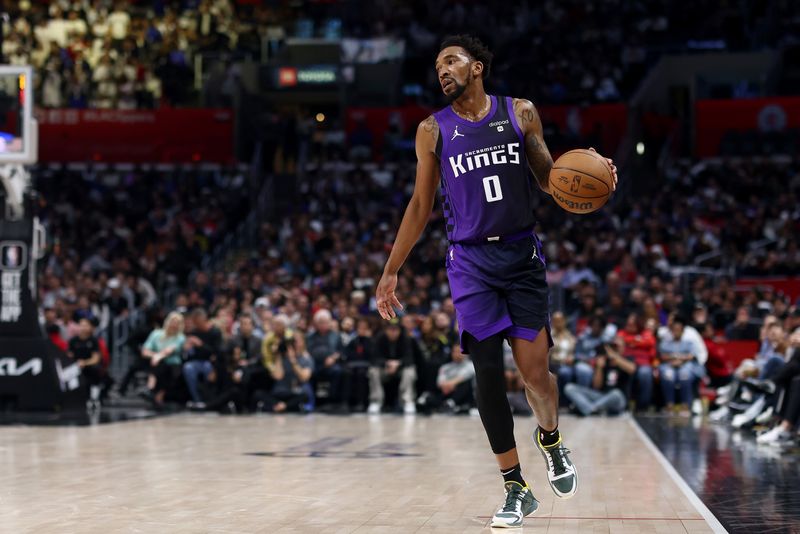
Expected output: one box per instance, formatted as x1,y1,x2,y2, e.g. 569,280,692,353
433,96,536,243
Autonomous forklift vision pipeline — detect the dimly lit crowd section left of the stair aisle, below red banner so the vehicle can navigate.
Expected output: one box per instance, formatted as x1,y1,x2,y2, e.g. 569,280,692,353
34,166,250,358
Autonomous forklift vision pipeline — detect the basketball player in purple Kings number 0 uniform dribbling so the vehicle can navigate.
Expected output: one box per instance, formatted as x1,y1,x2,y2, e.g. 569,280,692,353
376,35,616,527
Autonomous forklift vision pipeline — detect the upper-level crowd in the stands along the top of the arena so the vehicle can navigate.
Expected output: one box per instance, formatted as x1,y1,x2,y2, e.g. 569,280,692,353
2,0,786,109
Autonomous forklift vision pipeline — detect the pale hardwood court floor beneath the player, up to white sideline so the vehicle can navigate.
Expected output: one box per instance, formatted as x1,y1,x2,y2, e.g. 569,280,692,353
0,414,723,534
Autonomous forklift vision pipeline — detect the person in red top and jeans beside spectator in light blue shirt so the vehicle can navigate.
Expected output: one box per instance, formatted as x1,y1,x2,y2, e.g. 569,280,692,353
617,313,656,410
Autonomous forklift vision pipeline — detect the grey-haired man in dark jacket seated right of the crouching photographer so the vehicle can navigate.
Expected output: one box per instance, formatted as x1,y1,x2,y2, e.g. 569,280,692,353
306,309,350,411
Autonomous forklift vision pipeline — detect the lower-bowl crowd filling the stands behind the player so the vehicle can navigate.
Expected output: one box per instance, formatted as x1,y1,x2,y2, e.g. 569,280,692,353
39,152,800,436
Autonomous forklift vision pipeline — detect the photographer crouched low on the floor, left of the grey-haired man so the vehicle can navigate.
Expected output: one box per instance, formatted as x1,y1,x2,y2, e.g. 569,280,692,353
255,336,314,413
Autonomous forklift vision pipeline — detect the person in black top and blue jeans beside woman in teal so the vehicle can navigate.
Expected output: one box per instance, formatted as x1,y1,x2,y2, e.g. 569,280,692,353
183,308,224,410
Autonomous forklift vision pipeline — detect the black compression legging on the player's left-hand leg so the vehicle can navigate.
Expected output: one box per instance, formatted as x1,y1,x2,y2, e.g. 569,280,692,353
463,332,517,454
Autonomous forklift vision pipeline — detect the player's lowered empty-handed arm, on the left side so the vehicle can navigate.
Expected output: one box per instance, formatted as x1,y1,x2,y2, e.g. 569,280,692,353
375,115,439,319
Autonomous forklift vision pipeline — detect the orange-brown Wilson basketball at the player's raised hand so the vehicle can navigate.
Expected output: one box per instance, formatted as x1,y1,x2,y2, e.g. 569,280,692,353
550,148,614,213
